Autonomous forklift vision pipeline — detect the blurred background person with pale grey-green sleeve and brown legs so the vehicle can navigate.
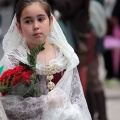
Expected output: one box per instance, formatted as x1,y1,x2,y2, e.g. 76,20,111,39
86,0,107,120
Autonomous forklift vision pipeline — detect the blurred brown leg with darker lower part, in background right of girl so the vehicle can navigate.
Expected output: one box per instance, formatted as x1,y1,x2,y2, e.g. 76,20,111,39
86,57,107,120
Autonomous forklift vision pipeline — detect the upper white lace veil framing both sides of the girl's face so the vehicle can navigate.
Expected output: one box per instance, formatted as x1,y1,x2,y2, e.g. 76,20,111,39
2,15,79,68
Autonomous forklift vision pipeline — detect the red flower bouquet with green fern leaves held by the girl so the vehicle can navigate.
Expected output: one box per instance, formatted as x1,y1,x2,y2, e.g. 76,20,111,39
0,44,44,97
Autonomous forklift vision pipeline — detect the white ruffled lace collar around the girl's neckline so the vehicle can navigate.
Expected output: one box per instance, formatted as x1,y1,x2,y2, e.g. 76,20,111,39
16,43,67,74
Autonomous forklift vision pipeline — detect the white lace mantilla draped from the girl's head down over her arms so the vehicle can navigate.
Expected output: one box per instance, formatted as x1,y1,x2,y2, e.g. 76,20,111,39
0,14,91,120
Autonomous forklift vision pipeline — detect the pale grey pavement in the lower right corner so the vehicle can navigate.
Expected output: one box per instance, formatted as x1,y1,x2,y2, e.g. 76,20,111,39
104,85,120,120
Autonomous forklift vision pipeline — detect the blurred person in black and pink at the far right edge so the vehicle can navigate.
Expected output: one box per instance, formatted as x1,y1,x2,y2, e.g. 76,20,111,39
111,0,120,80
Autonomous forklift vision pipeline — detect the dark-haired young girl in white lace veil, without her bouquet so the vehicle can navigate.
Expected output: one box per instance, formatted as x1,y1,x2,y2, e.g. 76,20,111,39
0,0,91,120
